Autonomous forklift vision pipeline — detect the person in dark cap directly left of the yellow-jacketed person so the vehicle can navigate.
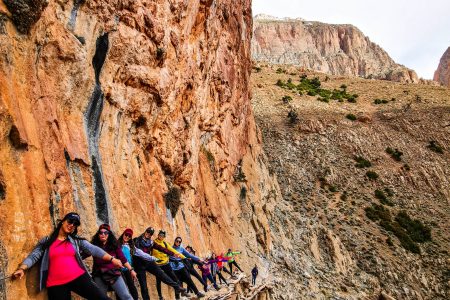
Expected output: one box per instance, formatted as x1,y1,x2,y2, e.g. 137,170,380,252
133,227,186,300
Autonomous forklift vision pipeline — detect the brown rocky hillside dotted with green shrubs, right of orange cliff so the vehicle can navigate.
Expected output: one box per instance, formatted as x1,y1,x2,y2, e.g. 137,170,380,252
252,64,450,300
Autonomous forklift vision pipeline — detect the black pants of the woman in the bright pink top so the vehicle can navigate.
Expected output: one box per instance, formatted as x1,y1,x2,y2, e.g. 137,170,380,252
47,273,111,300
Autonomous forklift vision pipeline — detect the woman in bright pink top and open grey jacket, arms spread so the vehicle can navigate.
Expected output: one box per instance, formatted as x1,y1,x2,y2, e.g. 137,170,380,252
13,212,123,300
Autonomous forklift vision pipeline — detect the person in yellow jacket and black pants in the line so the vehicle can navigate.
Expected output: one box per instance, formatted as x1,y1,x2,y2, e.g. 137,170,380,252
152,230,186,300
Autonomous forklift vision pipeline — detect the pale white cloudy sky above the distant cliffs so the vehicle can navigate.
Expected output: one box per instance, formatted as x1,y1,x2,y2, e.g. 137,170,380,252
252,0,450,79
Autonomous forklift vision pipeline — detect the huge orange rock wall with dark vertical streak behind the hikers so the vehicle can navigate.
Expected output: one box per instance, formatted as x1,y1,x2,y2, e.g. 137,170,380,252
0,0,274,299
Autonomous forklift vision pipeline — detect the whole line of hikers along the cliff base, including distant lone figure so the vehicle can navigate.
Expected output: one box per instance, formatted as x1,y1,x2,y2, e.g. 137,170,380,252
13,213,258,300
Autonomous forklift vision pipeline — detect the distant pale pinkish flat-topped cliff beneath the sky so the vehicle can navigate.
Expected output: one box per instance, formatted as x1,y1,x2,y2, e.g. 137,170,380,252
252,16,419,82
